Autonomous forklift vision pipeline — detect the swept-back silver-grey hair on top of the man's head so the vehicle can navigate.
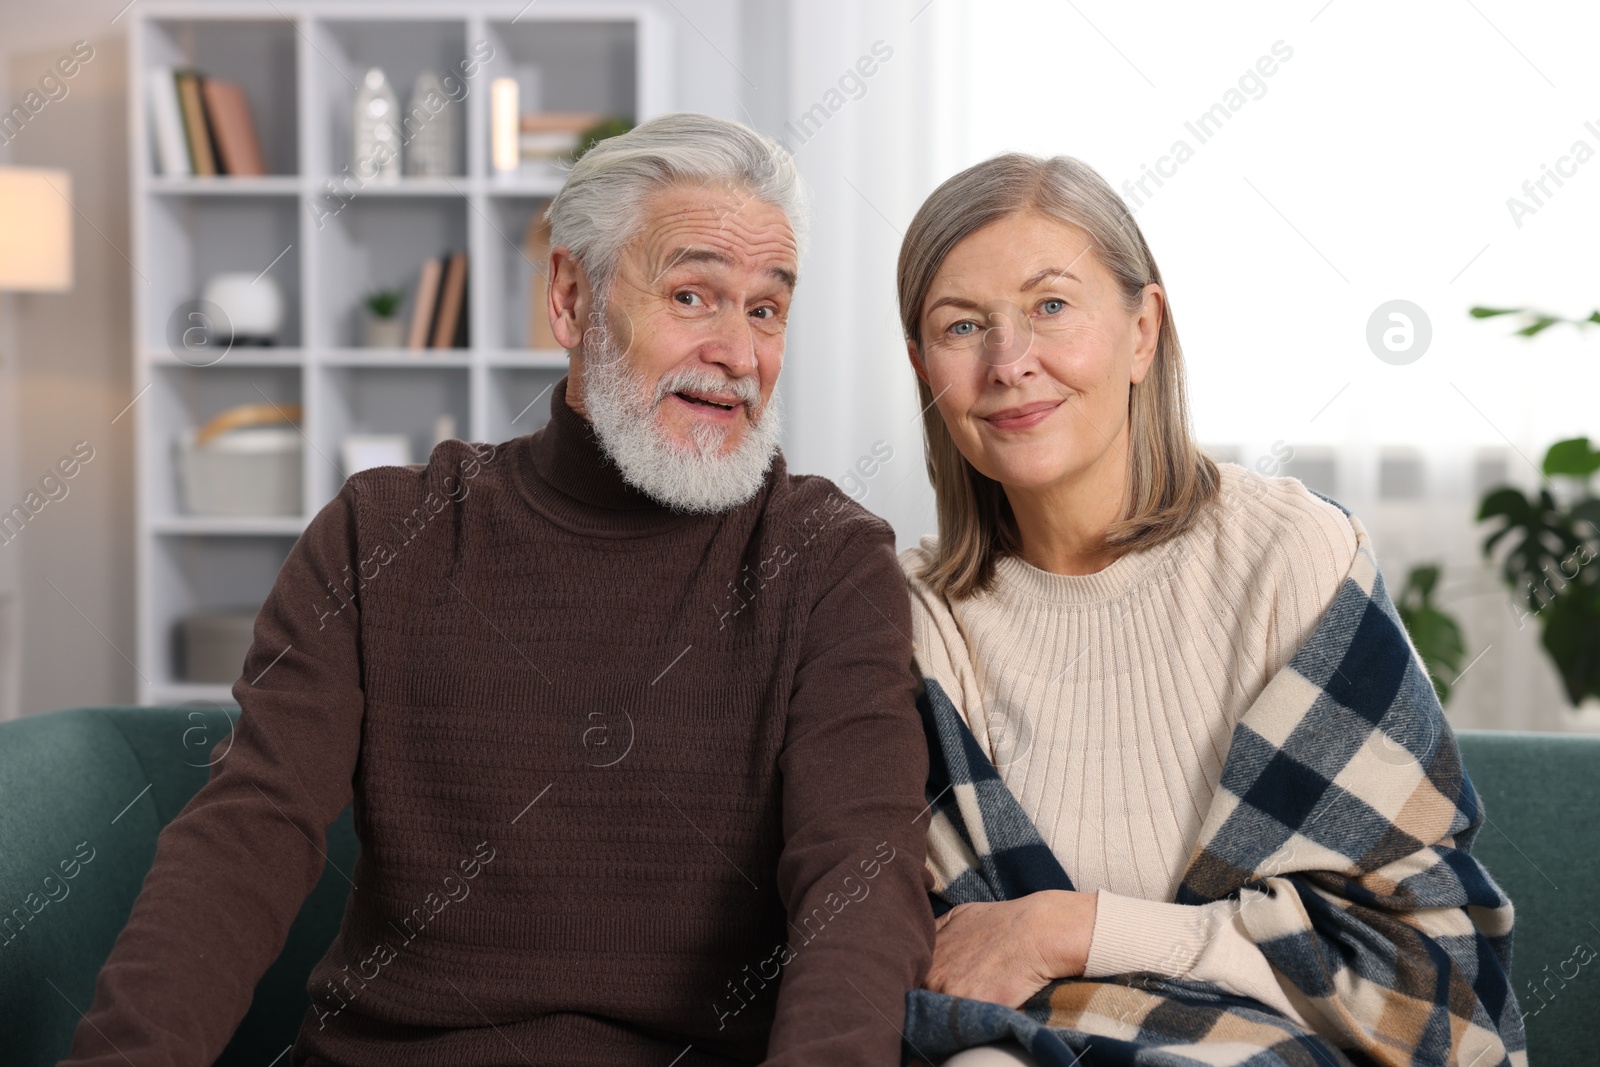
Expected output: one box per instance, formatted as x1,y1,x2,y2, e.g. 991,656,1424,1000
547,112,810,302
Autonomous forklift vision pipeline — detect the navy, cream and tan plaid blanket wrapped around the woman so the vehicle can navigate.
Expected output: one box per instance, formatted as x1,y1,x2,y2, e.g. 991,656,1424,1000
906,509,1528,1067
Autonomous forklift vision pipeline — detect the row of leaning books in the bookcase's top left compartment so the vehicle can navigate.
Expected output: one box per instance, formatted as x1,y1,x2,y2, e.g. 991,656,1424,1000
149,67,267,178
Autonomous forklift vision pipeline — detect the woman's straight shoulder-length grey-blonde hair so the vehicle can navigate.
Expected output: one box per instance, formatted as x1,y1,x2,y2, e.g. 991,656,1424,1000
898,152,1219,598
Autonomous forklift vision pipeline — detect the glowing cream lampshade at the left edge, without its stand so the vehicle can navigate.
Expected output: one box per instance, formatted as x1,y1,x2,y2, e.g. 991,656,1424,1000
0,166,72,293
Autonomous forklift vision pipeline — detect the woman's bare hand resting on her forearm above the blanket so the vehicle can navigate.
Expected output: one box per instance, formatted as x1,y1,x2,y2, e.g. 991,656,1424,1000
923,889,1094,1008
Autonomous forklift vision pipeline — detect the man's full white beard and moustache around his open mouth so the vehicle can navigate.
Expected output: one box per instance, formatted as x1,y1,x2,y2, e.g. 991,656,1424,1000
582,304,781,514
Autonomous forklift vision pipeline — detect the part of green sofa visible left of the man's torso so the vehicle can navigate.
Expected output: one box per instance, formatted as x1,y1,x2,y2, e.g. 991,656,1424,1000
0,705,357,1067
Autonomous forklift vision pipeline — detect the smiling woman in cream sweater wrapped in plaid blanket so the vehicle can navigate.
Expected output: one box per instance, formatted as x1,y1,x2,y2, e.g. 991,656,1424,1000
899,155,1525,1064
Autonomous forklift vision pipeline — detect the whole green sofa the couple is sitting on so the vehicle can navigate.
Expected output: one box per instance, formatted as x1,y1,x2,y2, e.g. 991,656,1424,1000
0,707,1600,1067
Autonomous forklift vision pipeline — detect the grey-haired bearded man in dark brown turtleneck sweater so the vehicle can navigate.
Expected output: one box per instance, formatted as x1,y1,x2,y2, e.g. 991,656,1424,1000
69,115,933,1067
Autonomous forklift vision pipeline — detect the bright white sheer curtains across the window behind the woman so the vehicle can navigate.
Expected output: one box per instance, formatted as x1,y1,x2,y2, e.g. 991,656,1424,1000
763,0,1600,729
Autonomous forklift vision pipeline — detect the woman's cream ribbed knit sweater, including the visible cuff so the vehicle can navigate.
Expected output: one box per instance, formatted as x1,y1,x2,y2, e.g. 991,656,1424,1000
901,464,1355,1025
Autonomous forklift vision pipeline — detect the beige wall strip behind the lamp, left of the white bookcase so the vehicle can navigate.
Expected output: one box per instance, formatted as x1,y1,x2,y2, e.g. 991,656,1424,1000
0,31,134,726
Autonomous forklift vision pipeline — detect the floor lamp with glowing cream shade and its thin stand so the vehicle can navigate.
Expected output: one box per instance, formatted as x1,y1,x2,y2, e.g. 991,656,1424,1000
0,166,72,721
